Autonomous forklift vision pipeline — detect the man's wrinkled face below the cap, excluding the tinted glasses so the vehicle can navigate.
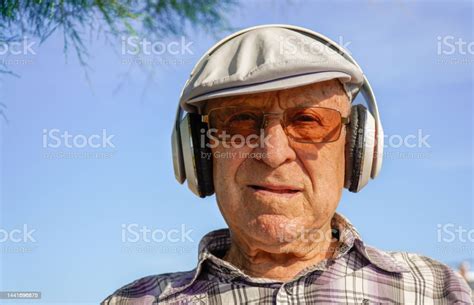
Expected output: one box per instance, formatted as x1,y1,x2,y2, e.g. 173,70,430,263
206,80,350,253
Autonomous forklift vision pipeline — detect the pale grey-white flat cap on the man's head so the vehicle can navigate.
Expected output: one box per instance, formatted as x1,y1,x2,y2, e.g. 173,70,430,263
180,26,364,112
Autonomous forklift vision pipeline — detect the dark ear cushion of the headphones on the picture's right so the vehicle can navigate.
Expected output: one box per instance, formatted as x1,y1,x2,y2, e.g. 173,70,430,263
344,104,367,193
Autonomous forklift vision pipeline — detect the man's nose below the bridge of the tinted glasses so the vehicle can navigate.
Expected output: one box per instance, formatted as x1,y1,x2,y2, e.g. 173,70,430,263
257,117,296,168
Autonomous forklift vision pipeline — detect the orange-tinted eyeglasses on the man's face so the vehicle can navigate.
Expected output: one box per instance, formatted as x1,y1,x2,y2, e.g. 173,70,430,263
202,106,349,143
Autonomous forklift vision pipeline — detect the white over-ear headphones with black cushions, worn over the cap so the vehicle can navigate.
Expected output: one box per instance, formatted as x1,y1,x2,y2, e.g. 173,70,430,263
171,24,384,198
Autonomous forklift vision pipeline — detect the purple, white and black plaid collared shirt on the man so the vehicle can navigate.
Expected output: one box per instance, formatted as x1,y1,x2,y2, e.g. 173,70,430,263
102,213,472,305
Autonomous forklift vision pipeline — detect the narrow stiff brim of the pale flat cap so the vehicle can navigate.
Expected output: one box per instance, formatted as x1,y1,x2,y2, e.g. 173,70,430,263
181,71,351,111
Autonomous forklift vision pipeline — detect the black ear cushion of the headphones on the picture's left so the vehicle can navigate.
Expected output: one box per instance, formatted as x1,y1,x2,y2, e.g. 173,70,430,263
188,113,214,198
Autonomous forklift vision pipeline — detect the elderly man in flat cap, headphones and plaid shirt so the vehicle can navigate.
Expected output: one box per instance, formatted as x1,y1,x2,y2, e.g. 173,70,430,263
103,25,471,304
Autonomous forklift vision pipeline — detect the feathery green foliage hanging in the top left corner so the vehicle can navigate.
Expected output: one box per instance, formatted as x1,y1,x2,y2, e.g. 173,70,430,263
0,0,235,66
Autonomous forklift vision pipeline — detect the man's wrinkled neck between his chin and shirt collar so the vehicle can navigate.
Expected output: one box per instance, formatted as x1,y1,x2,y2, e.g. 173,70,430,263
223,224,339,282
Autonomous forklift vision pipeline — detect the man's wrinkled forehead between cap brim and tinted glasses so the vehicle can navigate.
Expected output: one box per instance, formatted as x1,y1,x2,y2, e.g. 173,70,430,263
204,80,350,114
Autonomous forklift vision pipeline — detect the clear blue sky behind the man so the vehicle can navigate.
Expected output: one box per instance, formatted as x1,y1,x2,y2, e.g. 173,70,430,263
0,1,474,304
